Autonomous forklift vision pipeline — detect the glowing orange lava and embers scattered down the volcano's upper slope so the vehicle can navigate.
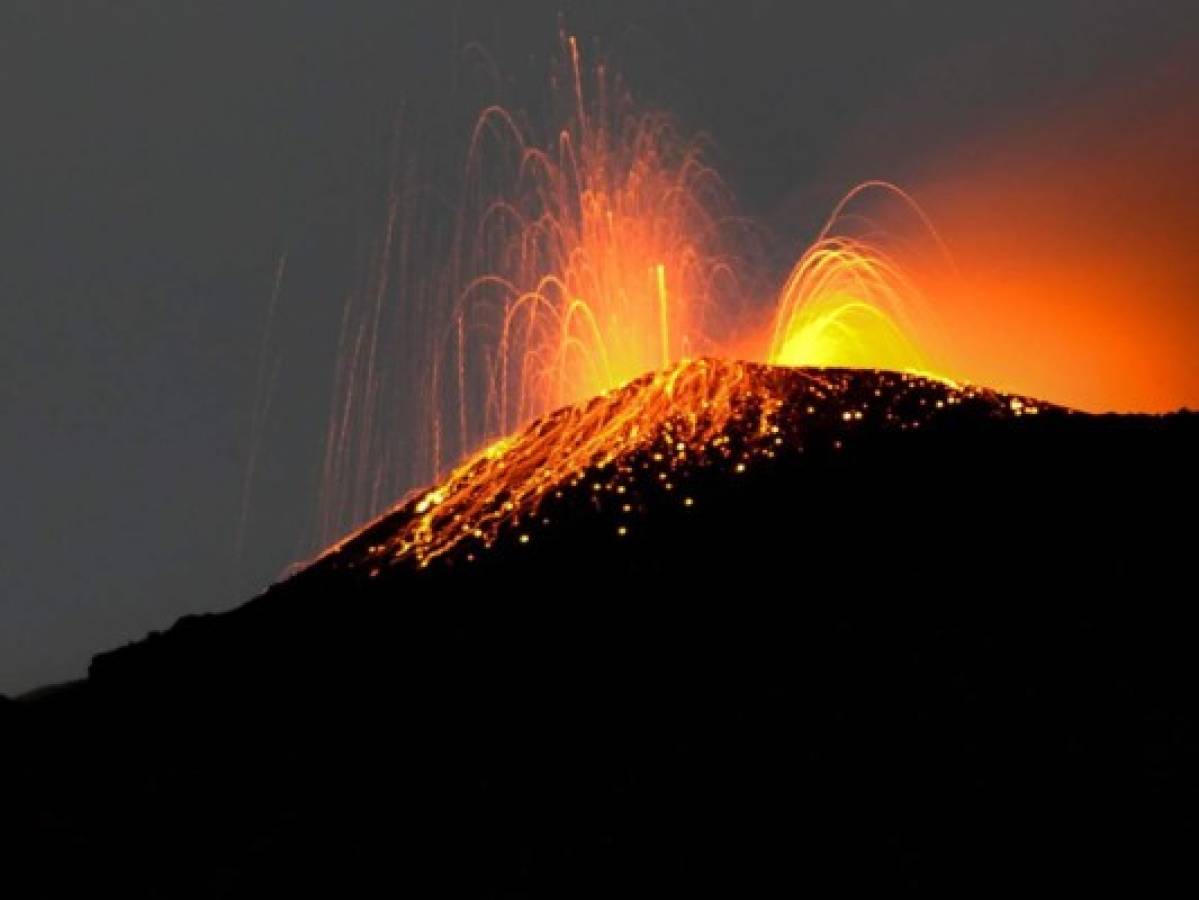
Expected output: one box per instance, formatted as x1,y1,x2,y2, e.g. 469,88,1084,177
323,358,1070,576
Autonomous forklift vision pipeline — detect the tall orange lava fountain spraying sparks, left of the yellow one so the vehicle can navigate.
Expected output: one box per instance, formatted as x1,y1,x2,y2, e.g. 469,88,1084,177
443,37,746,446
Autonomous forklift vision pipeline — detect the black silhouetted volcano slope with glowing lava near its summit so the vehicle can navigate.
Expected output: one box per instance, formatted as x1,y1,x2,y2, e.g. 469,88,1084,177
9,362,1199,896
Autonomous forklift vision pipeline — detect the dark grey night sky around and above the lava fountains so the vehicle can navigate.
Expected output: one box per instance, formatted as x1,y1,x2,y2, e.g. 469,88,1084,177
0,0,1199,694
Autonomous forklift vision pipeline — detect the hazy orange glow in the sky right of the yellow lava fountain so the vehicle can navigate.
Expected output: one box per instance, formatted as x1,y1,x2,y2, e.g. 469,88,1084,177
910,61,1199,411
